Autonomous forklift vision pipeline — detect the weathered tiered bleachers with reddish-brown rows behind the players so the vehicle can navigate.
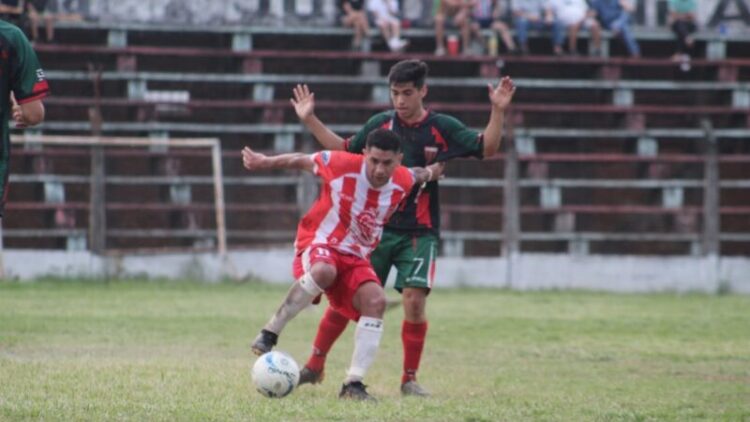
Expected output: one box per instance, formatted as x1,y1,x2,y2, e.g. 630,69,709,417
5,23,750,255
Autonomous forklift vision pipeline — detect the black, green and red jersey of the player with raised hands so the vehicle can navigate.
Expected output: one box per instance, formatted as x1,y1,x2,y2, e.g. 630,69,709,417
344,110,484,234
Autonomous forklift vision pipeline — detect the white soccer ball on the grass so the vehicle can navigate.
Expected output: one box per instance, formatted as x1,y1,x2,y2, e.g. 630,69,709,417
252,351,299,398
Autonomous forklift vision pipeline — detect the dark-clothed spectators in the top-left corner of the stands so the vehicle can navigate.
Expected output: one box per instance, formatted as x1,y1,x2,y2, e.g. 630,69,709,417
0,0,81,42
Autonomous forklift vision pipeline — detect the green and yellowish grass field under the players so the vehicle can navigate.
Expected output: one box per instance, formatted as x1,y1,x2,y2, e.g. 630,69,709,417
0,281,750,421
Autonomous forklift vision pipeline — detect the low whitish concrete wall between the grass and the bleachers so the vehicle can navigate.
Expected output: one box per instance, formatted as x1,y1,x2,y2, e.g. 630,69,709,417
3,249,750,294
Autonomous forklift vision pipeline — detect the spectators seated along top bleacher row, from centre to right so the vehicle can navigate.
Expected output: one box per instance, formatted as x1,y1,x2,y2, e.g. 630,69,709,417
339,0,697,61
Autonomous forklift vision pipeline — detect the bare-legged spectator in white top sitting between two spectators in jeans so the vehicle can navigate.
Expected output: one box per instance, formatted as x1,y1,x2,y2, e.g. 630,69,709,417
549,0,602,56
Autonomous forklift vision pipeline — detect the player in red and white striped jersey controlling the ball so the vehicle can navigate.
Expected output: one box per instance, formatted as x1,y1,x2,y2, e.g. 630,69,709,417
248,129,439,400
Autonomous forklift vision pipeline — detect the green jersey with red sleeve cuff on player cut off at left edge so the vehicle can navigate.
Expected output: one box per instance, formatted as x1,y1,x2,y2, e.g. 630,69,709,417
0,20,49,215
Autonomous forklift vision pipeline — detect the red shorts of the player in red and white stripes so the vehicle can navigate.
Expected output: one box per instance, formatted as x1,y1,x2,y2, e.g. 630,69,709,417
292,245,380,321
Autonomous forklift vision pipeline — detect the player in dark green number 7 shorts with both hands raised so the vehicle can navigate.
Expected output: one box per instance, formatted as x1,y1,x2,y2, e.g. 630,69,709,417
292,60,515,396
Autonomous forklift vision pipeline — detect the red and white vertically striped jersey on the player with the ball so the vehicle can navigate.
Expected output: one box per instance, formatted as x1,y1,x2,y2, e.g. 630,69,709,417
294,151,414,259
